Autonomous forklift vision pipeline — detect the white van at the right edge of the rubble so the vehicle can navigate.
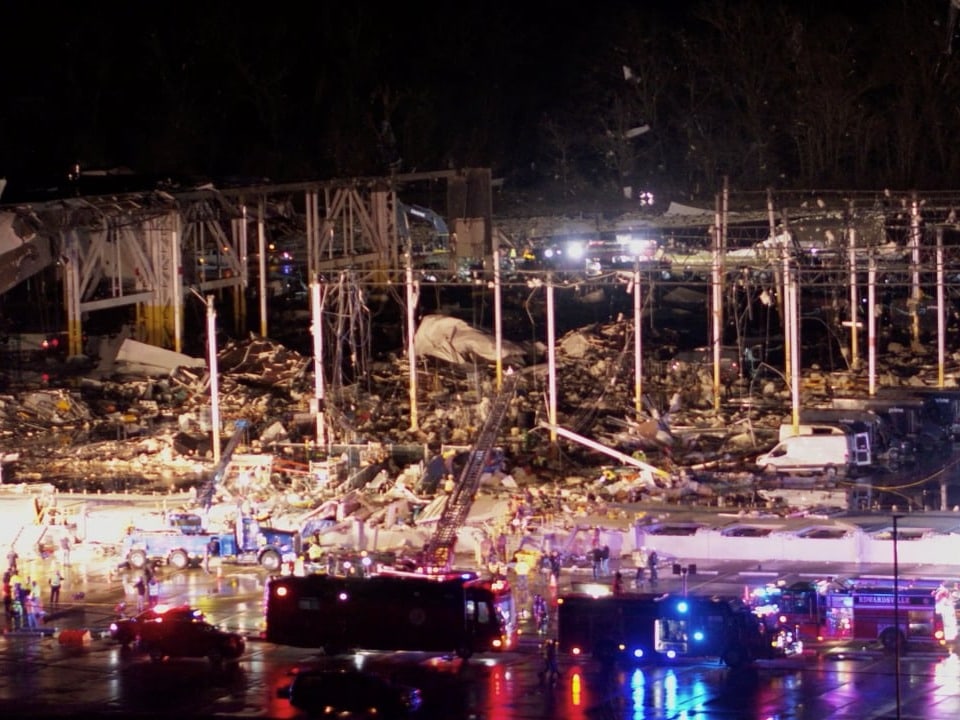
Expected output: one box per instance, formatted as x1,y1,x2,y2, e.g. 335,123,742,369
757,433,872,475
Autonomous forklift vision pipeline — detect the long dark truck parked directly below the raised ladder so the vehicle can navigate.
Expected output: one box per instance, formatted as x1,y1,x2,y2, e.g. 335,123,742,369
264,572,517,658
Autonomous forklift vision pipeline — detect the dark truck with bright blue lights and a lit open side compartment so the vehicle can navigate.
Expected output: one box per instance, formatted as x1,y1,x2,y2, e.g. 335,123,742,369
557,593,803,668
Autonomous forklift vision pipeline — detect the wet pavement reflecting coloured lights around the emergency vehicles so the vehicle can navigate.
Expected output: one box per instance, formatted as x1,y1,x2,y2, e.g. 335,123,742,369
0,558,960,720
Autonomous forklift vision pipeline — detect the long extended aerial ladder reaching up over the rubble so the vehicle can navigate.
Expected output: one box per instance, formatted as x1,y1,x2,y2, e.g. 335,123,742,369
423,374,519,570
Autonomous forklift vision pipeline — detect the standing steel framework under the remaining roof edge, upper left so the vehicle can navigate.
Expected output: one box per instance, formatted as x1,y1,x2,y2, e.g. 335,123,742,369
11,171,480,354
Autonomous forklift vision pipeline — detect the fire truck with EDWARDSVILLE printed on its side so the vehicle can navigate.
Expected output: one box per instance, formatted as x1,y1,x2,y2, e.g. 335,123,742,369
751,578,955,650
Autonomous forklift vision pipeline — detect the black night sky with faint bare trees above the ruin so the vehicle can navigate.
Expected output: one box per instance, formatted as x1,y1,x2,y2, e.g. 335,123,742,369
0,0,960,202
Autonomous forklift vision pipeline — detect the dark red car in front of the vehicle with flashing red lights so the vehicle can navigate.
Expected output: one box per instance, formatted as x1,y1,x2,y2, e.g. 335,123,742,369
139,616,247,665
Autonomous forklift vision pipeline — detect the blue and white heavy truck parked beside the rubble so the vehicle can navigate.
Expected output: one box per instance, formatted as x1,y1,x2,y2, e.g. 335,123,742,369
121,517,300,572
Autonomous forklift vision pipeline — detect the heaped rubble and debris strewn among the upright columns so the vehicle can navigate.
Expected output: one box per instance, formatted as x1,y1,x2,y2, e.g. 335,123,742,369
0,317,957,557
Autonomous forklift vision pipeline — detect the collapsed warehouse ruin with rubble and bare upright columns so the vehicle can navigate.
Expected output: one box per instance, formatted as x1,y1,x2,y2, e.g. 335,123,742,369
0,180,957,564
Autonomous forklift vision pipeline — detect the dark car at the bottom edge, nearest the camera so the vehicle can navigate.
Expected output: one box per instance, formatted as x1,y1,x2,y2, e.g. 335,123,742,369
277,669,423,718
